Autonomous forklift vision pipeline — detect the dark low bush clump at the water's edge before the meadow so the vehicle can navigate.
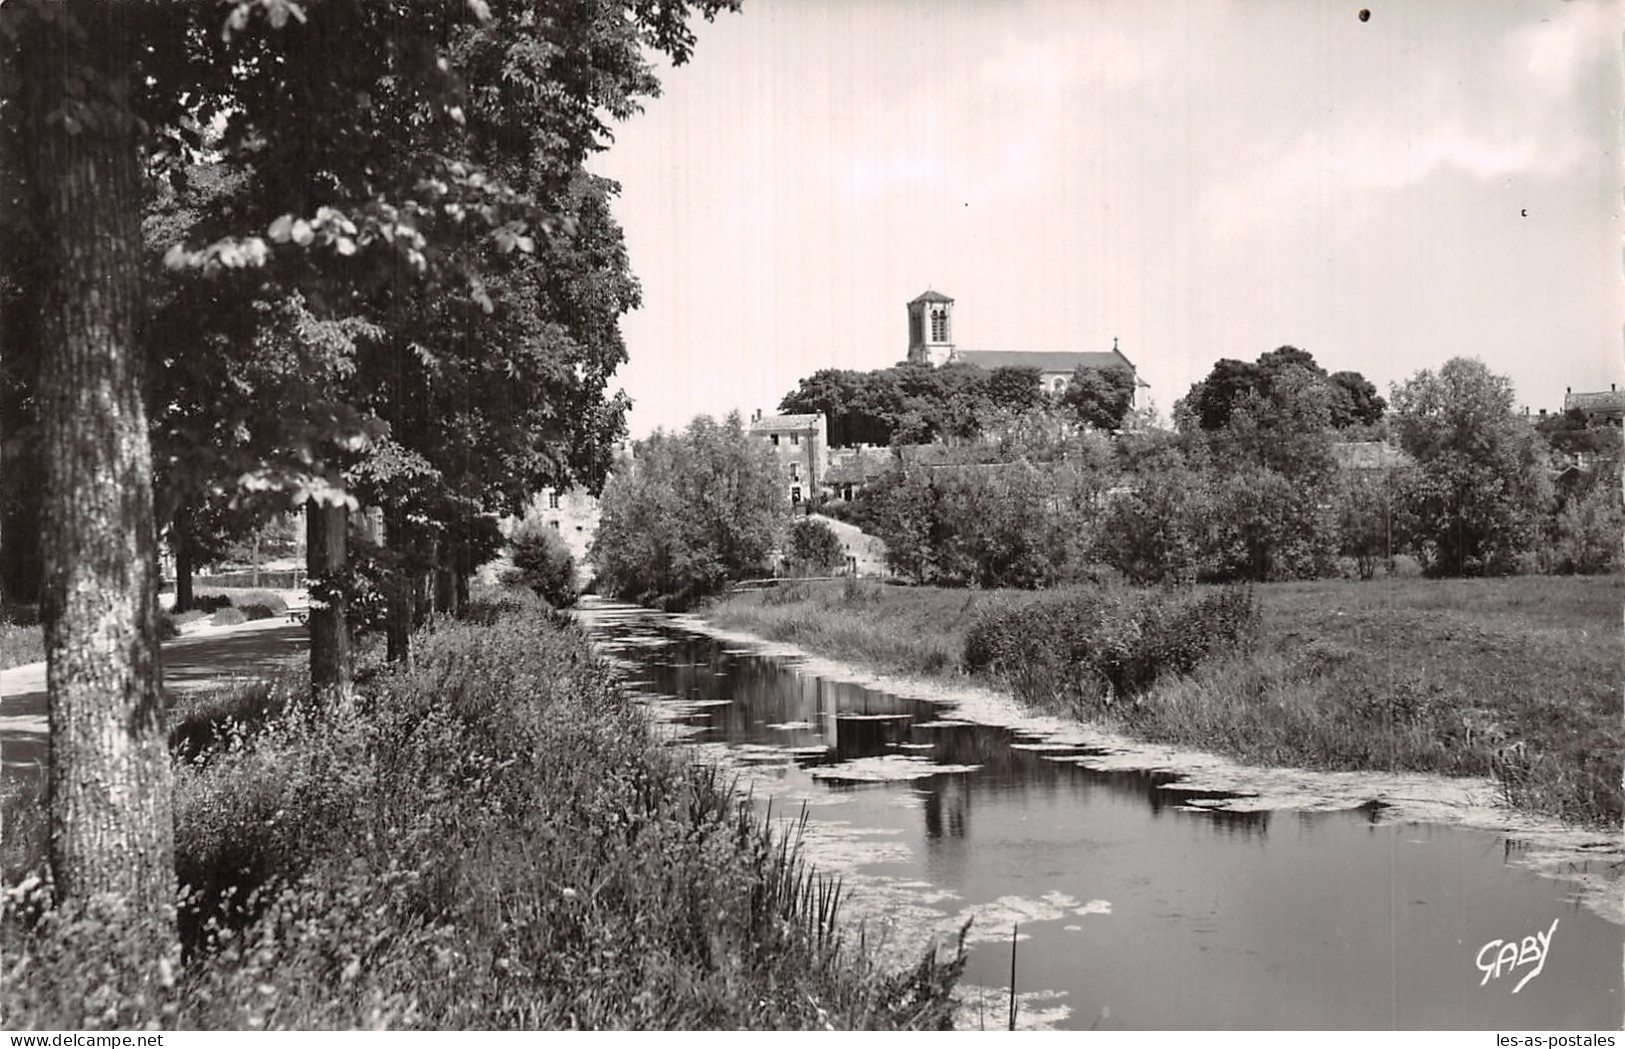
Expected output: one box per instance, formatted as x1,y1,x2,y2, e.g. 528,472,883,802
964,588,1259,713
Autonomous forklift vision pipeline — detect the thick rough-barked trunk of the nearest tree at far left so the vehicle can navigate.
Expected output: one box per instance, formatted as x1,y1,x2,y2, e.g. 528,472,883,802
18,3,176,940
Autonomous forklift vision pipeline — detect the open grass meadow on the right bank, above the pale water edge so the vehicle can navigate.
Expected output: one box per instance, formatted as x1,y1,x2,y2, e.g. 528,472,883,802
702,575,1625,827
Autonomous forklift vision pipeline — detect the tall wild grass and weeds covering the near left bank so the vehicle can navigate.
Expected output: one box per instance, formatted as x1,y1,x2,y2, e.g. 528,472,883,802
0,601,962,1030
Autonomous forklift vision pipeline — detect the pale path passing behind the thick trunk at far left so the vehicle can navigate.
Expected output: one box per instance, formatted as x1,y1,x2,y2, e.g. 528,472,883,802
0,619,309,776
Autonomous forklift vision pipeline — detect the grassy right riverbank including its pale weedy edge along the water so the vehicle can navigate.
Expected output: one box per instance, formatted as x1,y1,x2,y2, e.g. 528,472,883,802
689,578,1625,922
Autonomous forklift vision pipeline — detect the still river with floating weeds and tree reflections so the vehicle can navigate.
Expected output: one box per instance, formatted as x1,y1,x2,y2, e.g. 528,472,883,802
579,599,1625,1031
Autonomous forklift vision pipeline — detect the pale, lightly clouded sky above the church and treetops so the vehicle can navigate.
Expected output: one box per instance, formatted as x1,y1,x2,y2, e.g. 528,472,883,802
590,0,1625,437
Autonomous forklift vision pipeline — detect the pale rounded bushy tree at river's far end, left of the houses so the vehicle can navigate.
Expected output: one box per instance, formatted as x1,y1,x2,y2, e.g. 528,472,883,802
588,414,790,604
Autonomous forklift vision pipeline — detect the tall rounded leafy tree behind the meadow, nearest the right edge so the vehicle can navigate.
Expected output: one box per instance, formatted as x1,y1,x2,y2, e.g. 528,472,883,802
1391,357,1552,575
